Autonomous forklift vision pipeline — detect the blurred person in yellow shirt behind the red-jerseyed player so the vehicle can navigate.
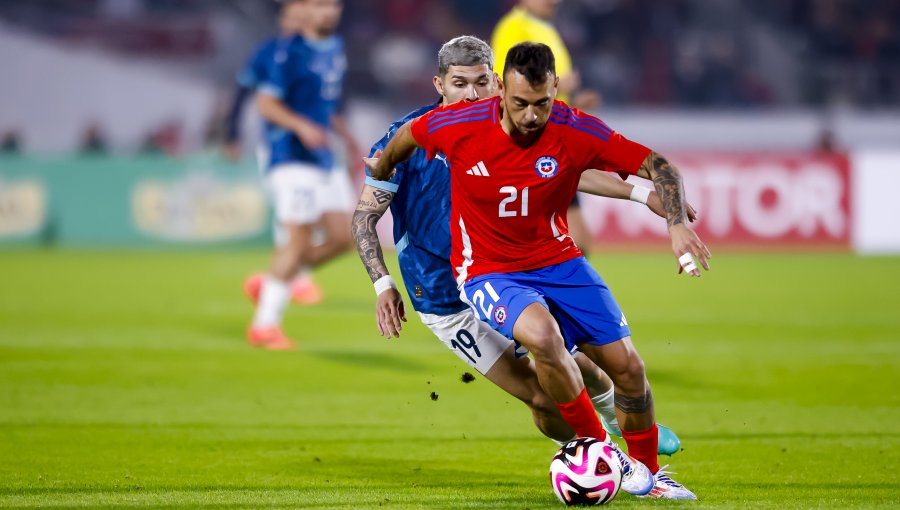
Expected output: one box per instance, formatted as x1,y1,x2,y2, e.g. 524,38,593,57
491,0,600,255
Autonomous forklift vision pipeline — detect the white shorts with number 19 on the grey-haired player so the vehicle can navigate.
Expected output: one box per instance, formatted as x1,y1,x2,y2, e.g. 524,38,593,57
419,310,528,375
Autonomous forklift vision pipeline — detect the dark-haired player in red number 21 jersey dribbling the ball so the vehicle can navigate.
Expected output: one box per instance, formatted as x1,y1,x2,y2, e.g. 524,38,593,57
367,43,710,499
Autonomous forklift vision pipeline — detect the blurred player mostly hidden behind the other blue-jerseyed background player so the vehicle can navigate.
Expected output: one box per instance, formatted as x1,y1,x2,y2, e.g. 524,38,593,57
223,0,330,304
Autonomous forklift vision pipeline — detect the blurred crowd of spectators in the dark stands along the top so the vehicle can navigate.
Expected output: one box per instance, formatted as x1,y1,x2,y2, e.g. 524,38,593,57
0,0,900,116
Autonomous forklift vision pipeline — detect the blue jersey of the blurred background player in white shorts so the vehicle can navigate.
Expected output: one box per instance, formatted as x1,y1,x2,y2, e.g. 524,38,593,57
259,35,347,171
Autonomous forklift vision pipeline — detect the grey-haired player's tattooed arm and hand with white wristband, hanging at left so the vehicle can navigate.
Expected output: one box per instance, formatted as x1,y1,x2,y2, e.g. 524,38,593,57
351,180,406,338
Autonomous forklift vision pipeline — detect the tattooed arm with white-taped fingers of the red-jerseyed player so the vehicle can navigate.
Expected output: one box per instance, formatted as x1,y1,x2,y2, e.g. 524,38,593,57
641,151,712,276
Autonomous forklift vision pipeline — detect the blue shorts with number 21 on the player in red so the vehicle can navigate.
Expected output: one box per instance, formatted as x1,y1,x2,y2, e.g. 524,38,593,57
462,257,631,349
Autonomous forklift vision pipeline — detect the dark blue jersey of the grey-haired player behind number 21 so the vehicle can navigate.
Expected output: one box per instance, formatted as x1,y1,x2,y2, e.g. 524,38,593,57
366,103,468,315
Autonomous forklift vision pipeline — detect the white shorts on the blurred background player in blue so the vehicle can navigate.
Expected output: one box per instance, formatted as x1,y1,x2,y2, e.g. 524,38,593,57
266,163,353,225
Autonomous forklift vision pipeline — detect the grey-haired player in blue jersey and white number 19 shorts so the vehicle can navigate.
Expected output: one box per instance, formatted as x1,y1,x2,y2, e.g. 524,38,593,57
353,36,694,494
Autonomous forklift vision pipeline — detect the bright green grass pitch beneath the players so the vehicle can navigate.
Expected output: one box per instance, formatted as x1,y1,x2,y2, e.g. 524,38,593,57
0,250,900,510
